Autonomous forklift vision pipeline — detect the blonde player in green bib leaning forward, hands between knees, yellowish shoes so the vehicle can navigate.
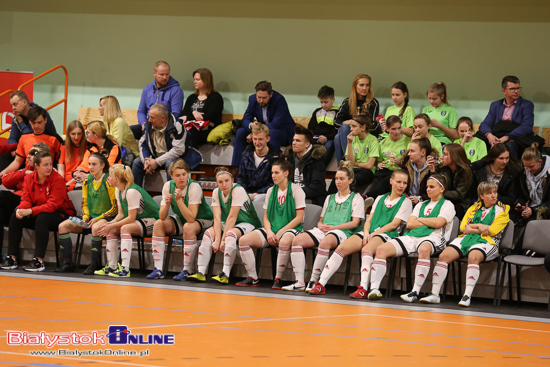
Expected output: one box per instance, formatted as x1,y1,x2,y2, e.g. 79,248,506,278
187,166,261,284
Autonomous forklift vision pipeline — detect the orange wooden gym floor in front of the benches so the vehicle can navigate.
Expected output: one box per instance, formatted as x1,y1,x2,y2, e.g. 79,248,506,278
0,271,550,367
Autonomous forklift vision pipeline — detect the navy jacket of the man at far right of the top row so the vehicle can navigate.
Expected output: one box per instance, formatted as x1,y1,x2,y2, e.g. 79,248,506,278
479,97,535,139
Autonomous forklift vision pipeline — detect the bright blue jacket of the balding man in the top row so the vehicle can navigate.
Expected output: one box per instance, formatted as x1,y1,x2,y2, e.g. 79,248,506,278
138,77,183,126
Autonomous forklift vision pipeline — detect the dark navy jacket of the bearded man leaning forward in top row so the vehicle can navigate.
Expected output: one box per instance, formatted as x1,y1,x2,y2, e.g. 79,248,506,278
243,91,296,135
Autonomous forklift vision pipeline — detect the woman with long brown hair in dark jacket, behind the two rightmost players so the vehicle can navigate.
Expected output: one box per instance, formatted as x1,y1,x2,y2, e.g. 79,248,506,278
436,144,473,219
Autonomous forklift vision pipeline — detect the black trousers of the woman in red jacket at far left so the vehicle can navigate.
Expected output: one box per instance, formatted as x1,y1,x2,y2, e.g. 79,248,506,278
8,211,69,258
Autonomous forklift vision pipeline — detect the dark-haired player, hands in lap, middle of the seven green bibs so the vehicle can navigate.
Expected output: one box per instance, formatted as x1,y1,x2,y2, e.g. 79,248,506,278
237,160,306,289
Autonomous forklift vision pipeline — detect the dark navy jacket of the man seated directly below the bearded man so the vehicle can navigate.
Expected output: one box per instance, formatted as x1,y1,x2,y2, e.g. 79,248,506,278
237,143,279,194
